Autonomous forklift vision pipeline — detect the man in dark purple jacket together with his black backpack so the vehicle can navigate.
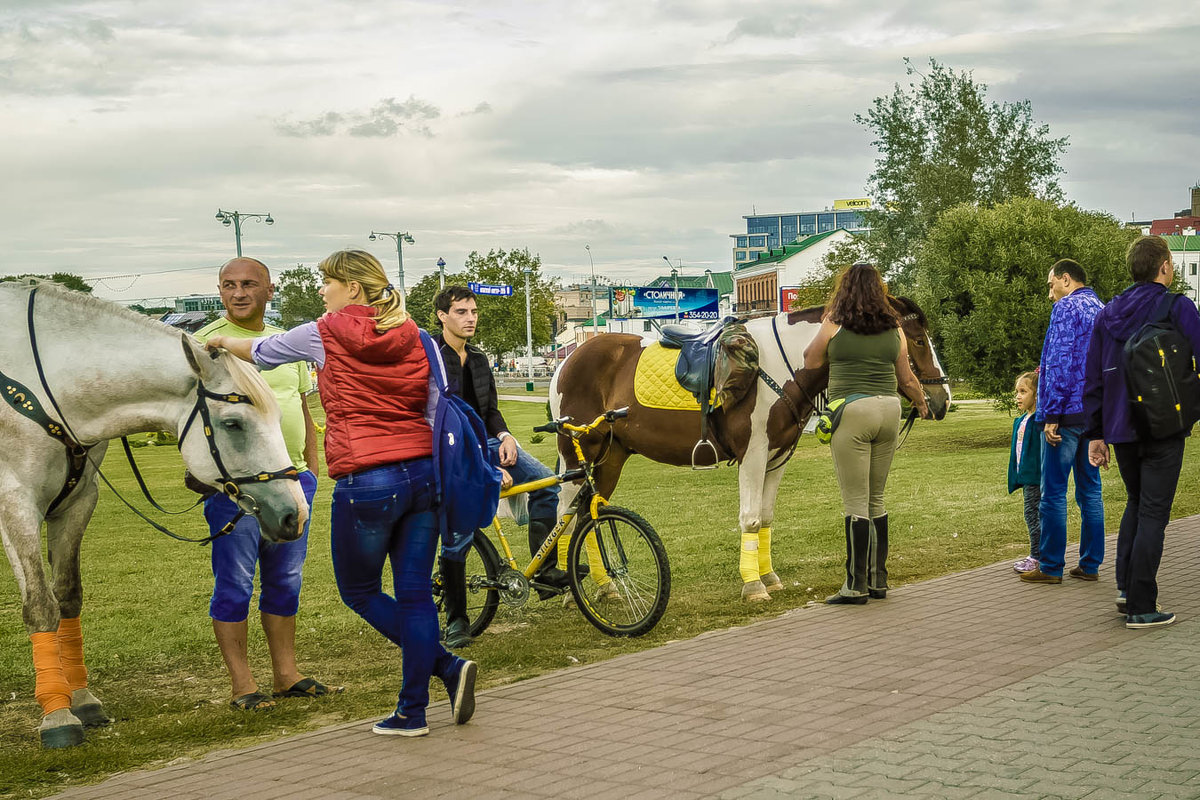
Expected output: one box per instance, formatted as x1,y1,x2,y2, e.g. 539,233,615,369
1084,236,1200,628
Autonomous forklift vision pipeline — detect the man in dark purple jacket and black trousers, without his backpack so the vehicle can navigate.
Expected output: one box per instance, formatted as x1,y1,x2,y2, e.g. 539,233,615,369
1084,236,1200,628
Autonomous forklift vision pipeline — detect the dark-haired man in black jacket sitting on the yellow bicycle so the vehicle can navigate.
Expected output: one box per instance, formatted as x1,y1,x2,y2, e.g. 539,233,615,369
433,285,568,648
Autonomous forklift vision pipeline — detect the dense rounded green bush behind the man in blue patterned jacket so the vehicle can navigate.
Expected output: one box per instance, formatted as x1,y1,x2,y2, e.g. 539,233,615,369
916,198,1138,404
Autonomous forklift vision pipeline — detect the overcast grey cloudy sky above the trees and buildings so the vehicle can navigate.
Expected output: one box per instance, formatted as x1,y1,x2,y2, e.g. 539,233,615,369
0,0,1200,301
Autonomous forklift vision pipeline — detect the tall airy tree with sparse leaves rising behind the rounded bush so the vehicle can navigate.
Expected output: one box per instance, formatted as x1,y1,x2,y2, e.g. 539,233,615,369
854,59,1067,290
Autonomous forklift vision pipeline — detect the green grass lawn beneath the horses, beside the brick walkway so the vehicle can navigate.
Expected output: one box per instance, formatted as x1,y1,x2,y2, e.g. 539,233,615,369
0,402,1200,798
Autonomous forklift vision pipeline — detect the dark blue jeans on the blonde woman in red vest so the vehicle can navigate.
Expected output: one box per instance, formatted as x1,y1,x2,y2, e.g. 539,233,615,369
332,458,460,721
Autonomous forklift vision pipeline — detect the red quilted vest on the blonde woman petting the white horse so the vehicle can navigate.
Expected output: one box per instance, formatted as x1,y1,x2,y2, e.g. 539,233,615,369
317,306,433,479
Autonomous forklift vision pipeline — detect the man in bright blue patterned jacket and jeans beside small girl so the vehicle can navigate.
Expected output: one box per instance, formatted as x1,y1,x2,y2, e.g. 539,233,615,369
1021,258,1104,583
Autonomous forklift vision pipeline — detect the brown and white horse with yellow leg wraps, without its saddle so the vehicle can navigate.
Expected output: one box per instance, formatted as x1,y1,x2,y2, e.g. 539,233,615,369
550,297,950,601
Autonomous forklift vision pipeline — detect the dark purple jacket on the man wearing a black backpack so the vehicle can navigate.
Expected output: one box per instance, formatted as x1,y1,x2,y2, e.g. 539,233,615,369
1084,283,1200,444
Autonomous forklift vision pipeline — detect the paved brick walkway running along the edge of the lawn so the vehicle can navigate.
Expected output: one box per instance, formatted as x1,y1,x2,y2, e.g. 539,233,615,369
49,517,1200,800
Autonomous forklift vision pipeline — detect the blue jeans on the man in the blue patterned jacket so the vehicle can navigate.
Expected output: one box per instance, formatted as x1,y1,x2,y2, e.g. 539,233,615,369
1038,427,1104,577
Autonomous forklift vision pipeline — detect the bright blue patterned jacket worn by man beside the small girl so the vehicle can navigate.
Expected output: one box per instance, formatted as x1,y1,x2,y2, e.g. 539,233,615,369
1037,287,1104,427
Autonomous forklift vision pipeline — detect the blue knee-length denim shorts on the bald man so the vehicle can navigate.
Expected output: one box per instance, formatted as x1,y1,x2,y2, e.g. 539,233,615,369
204,469,317,622
